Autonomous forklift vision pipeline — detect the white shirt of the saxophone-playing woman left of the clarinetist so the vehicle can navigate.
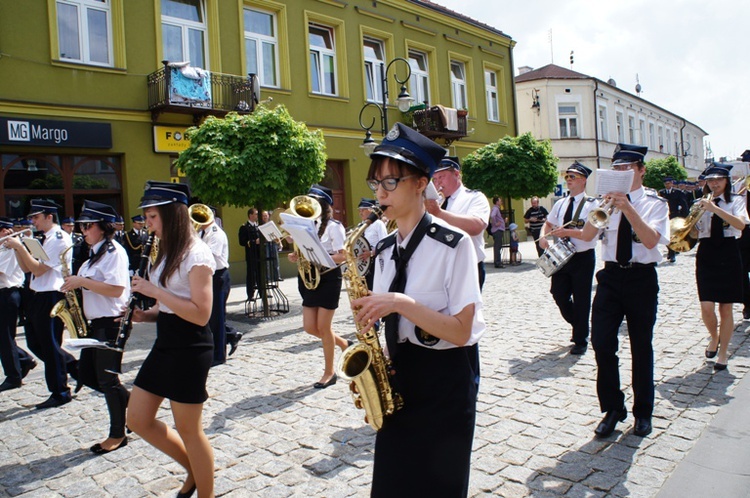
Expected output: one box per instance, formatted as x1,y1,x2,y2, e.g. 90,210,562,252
78,240,130,320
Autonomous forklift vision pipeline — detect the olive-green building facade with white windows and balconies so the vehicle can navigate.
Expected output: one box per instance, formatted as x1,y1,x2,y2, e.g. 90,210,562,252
0,0,517,283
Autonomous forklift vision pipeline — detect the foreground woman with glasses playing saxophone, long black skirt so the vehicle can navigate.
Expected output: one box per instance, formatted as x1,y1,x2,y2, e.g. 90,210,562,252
351,123,486,497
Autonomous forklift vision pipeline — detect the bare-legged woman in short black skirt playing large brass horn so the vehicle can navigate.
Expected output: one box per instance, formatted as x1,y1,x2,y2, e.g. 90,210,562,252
288,185,349,389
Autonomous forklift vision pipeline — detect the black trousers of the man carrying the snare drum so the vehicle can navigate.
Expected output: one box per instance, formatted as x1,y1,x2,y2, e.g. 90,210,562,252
550,249,596,346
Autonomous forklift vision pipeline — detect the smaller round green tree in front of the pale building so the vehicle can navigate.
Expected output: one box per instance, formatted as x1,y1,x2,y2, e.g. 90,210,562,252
461,133,558,205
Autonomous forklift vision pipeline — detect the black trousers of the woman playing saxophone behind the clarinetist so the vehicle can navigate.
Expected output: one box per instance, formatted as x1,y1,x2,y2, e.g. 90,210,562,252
78,318,130,439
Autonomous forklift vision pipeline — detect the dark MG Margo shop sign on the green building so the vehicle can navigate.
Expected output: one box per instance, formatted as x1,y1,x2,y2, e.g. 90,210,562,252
0,117,112,149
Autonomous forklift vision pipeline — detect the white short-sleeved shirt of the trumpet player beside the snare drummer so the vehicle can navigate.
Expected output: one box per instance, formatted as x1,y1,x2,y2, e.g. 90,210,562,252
602,187,669,264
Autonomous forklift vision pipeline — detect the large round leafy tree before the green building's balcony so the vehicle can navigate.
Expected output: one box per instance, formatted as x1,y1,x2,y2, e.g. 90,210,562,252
177,105,326,209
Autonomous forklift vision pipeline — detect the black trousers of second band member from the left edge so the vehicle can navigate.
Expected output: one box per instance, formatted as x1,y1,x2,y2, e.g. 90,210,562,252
26,291,77,399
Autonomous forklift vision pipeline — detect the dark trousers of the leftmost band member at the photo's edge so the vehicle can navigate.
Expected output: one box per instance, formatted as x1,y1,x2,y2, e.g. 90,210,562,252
0,287,33,384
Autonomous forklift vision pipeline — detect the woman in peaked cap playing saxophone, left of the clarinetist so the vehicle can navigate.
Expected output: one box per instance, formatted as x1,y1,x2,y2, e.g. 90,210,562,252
61,200,130,455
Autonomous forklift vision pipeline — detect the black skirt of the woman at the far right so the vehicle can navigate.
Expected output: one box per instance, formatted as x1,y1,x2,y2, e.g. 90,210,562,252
695,237,742,303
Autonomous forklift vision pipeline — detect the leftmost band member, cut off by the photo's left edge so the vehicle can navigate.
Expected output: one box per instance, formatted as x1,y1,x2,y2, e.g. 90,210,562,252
0,218,36,392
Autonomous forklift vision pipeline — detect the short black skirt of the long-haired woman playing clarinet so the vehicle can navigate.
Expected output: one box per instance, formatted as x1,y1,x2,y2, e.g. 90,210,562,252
133,313,214,403
